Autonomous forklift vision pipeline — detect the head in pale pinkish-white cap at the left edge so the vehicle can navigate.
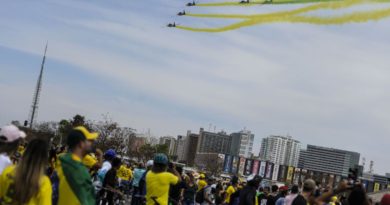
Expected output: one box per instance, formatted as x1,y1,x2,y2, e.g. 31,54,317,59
0,125,26,156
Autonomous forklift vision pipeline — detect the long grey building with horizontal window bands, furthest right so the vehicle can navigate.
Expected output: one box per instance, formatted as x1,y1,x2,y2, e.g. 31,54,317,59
298,145,360,177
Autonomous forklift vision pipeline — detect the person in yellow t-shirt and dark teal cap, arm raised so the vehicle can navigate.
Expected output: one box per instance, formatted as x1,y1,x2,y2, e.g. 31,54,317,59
146,153,181,205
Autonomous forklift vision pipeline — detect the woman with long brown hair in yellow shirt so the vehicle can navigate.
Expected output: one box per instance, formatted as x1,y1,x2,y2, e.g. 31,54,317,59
0,139,52,205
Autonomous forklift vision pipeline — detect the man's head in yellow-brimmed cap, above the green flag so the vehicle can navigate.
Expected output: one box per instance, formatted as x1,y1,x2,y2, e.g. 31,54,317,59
67,126,99,157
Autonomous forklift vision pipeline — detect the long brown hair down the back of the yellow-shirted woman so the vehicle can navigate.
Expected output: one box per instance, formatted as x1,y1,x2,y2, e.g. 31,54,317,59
14,139,49,204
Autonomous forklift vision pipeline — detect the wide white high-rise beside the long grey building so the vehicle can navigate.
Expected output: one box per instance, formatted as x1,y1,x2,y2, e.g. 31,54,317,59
259,135,301,167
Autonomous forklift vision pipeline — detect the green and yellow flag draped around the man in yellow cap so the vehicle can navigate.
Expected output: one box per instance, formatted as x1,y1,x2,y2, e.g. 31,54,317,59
56,153,95,205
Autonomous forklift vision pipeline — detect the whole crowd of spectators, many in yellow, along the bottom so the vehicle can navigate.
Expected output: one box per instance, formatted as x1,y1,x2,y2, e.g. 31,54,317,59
0,125,390,205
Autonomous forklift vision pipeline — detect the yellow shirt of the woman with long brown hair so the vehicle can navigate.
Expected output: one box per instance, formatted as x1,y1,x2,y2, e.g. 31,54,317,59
0,166,52,205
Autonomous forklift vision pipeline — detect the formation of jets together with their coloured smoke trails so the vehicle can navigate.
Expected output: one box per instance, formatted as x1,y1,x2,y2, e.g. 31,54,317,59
167,0,390,32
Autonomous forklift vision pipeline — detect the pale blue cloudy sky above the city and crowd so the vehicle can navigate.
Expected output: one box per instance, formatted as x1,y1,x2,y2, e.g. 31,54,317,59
0,0,390,173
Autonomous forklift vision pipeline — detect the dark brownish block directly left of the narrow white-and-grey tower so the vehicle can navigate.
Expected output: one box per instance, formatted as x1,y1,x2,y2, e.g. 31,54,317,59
197,128,233,154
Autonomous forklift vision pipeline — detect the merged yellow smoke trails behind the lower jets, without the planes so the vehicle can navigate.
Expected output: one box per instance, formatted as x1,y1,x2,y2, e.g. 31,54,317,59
177,0,390,32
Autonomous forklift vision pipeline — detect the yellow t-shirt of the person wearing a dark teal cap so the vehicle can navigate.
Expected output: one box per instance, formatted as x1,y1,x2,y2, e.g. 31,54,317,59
146,171,179,205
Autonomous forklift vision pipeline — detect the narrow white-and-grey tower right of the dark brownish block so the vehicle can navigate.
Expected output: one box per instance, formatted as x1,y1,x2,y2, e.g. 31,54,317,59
230,130,255,158
